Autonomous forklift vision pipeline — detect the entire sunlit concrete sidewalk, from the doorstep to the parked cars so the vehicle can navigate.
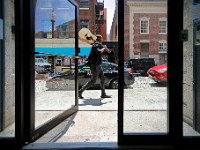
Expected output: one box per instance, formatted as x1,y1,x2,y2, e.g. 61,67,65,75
32,87,199,143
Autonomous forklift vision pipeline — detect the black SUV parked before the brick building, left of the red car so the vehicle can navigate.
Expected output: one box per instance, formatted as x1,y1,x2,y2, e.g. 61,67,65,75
124,58,156,76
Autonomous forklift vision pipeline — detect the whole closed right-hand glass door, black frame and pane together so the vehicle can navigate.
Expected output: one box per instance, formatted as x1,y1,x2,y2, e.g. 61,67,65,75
118,0,182,145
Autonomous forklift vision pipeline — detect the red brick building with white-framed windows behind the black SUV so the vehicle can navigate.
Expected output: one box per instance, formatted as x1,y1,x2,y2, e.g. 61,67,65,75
110,0,167,64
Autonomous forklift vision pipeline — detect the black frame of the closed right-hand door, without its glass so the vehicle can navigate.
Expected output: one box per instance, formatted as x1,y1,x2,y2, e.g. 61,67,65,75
118,0,183,145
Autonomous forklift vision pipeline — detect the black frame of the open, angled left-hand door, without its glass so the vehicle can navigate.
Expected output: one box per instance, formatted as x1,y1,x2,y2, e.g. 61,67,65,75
20,0,79,143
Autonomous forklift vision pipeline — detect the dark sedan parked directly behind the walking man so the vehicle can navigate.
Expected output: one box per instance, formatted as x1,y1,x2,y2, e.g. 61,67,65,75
52,62,135,89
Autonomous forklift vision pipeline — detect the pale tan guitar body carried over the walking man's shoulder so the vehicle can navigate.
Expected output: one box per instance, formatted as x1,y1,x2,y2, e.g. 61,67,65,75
78,28,97,44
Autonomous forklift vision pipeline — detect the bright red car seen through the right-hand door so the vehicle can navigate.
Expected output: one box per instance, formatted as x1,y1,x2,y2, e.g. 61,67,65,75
147,65,167,82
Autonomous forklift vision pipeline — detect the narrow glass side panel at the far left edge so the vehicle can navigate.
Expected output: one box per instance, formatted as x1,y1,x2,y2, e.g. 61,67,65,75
0,0,15,137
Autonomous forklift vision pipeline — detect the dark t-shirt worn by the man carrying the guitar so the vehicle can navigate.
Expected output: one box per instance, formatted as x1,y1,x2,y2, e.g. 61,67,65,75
88,42,103,66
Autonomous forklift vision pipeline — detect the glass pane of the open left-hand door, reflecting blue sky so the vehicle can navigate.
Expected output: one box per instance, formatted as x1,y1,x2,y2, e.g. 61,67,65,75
35,0,75,127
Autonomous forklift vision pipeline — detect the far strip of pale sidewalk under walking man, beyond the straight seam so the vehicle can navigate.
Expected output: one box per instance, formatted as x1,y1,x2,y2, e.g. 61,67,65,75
36,87,167,110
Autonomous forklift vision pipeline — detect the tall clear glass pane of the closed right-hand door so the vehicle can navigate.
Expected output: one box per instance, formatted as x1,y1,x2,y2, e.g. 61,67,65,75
123,0,168,133
